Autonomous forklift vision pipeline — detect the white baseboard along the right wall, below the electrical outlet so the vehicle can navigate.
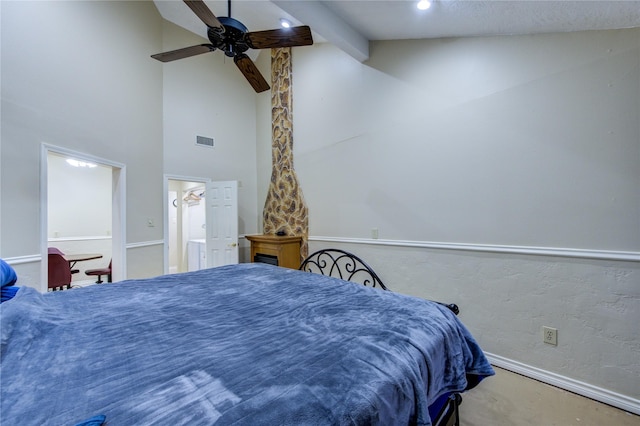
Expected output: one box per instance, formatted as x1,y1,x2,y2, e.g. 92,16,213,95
485,352,640,415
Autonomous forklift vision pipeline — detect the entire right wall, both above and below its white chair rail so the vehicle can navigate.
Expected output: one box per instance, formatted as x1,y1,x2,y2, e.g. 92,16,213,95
259,29,640,411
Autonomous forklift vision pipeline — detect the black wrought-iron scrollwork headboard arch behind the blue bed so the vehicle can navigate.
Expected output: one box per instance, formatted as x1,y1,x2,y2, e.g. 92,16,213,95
298,249,388,290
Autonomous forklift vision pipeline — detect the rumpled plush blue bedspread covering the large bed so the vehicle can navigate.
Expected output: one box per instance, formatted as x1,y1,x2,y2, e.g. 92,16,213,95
0,264,493,426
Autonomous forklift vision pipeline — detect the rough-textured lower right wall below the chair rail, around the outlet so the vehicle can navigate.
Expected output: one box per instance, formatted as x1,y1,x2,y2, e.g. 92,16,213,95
310,242,640,400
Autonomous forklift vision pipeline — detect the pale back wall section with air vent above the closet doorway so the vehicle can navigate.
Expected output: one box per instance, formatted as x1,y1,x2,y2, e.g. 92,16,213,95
163,21,269,240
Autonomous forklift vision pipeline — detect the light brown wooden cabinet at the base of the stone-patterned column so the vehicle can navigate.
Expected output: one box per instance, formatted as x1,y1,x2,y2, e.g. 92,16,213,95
245,235,302,269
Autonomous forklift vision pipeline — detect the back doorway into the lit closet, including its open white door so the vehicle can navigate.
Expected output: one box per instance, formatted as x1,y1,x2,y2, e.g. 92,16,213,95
164,176,239,274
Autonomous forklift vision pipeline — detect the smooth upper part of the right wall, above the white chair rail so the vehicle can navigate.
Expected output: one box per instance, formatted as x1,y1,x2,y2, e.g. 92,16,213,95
294,30,640,251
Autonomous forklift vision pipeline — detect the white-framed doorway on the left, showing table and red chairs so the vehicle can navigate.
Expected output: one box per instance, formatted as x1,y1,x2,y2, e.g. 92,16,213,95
41,144,125,291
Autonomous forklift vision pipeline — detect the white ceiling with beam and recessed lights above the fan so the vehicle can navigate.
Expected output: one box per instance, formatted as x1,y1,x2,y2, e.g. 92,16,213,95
154,0,640,61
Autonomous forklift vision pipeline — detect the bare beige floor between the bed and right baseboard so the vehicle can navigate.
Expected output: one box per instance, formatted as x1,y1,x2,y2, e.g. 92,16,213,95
460,367,640,426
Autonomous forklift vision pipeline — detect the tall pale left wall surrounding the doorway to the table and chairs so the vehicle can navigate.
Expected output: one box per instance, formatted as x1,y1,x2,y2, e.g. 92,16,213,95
0,1,163,286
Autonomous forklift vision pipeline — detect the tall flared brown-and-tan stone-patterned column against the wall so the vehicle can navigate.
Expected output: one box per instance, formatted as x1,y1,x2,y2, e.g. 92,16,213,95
263,48,309,258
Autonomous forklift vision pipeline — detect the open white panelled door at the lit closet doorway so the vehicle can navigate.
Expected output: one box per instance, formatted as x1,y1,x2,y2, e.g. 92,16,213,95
205,180,238,268
